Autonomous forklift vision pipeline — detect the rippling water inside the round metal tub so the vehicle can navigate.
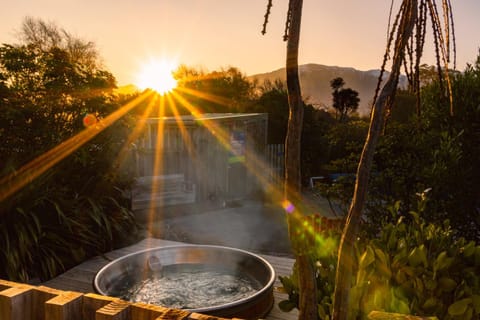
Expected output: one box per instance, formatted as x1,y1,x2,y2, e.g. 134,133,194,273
110,264,261,309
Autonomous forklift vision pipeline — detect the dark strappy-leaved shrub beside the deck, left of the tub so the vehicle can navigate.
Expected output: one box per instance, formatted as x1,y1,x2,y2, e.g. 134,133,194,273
0,174,138,282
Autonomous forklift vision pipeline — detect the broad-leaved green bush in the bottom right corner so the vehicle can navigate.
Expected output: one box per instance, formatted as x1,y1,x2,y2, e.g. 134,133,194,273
351,199,480,319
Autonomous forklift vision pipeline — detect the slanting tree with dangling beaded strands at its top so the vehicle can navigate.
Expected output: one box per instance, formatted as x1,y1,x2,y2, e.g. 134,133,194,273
333,0,453,320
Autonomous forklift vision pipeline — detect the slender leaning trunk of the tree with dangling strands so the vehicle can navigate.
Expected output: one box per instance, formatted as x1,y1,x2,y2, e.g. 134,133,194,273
333,0,418,320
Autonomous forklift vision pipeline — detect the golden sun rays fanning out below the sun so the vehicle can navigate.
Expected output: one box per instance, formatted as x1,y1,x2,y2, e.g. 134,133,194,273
0,68,338,262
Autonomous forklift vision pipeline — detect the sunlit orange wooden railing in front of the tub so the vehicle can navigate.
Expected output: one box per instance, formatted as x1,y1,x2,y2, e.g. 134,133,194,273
0,279,242,320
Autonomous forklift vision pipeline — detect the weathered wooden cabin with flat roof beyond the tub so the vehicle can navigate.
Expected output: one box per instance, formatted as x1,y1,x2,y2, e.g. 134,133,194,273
132,113,268,210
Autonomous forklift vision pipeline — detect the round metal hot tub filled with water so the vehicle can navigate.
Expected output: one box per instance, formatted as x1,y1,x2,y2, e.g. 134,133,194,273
94,245,275,319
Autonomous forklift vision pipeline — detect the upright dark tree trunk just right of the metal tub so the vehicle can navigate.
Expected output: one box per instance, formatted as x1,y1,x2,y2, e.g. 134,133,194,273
285,0,317,320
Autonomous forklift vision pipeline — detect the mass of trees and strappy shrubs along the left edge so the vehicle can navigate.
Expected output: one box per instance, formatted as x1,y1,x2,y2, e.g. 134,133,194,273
0,18,141,281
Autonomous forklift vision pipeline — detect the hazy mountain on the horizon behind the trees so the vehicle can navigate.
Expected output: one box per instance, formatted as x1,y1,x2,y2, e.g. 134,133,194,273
248,63,406,115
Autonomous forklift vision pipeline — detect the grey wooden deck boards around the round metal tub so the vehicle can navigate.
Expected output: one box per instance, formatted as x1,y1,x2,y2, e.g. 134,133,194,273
42,238,298,320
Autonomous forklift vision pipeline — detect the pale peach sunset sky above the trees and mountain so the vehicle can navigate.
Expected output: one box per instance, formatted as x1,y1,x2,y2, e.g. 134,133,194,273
0,0,480,85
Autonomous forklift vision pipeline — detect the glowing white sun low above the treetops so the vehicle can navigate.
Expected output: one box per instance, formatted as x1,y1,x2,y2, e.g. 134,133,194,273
136,60,177,94
